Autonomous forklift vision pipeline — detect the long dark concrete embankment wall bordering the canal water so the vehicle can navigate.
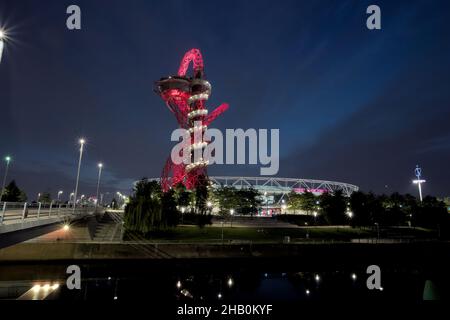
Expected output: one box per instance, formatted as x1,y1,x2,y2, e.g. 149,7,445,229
0,242,450,265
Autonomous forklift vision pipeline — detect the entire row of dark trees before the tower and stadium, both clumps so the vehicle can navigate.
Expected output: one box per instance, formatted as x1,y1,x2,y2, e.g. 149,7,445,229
125,179,449,233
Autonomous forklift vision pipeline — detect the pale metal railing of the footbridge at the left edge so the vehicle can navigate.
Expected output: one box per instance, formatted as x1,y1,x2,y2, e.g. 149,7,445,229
0,201,93,225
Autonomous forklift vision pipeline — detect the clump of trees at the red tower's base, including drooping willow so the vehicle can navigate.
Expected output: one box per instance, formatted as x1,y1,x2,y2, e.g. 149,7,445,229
124,178,260,234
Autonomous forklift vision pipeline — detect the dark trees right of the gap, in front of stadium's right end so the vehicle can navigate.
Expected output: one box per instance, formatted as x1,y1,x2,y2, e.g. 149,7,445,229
288,191,449,228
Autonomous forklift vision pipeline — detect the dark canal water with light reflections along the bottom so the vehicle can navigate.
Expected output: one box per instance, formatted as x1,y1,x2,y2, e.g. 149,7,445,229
0,259,450,303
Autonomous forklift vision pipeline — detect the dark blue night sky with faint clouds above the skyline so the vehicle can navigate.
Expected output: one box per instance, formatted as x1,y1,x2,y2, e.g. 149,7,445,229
0,0,450,200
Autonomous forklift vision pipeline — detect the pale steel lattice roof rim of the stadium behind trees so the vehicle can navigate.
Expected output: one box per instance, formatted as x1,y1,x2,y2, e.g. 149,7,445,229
149,176,359,197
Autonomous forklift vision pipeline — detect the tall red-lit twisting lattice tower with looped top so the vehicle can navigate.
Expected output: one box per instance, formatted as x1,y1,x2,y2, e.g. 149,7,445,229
155,49,228,192
